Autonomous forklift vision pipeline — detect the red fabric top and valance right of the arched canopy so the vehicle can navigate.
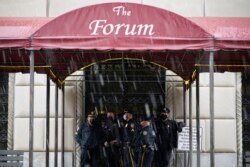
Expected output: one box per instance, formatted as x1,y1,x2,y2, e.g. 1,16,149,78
189,17,250,49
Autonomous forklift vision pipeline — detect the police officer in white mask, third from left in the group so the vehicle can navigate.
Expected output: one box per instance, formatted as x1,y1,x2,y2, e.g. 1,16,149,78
120,110,138,167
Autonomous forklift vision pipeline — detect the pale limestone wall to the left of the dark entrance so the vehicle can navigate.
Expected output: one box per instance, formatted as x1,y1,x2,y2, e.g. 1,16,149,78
9,73,76,167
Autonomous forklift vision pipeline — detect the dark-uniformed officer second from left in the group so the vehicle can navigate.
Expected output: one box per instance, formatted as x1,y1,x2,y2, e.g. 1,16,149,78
104,112,121,167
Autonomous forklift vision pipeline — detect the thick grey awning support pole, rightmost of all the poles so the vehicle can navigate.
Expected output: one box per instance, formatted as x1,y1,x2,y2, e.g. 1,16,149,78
209,51,214,167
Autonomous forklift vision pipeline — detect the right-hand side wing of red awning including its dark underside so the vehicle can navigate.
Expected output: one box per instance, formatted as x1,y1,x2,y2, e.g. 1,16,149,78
189,17,250,72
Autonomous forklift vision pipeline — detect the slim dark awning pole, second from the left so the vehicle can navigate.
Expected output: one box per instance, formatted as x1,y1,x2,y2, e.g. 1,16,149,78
45,72,50,167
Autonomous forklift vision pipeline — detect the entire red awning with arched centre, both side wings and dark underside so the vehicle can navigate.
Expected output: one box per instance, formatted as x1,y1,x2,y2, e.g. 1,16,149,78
0,3,250,81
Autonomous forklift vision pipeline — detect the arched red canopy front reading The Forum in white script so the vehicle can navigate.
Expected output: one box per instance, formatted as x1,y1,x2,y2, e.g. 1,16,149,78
31,3,212,50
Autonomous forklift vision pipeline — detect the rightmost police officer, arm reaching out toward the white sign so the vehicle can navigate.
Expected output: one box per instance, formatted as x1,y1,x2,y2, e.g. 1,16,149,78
156,107,184,167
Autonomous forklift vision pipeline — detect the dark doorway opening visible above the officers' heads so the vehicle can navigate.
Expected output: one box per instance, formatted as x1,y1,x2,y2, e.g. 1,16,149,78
85,59,166,114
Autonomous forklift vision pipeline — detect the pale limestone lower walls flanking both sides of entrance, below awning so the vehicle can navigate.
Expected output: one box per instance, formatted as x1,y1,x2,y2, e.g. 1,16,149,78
9,73,241,167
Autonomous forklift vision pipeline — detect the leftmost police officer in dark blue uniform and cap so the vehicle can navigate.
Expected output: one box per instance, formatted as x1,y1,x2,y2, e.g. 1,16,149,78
76,112,102,167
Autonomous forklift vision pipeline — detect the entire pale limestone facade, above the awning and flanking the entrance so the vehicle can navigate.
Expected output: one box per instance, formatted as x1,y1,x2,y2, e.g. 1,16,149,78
0,0,245,167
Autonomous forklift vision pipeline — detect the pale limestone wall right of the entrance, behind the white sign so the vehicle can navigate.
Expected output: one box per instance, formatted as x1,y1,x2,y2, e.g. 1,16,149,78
174,72,242,167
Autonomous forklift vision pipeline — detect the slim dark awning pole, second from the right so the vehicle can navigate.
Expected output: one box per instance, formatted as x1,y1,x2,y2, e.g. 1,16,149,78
196,66,201,167
